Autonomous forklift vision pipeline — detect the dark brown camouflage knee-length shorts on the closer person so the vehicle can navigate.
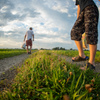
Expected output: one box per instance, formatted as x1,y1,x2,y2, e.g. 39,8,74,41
71,5,99,45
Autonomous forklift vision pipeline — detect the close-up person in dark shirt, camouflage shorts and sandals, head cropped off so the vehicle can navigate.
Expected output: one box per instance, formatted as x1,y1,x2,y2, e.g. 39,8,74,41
71,0,100,70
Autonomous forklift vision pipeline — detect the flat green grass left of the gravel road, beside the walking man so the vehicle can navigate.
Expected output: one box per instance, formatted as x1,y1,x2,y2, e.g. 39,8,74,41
0,49,36,59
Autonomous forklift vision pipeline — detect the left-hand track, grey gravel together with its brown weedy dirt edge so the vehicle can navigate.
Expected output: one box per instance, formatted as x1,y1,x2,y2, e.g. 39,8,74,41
0,54,29,91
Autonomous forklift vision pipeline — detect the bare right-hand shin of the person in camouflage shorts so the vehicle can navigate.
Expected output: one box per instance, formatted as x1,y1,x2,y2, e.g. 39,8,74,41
89,44,97,66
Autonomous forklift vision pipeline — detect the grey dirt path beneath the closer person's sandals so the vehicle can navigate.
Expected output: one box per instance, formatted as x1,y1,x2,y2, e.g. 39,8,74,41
59,55,100,73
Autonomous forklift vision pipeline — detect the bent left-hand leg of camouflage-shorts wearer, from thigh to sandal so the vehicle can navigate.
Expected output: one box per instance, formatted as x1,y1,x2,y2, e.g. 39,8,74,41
71,12,88,61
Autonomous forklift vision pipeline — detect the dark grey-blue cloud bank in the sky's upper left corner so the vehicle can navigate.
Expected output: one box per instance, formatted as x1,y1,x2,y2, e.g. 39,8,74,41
0,0,39,26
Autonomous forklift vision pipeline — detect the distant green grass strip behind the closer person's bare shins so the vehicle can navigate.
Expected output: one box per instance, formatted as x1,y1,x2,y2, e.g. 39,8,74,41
53,50,100,62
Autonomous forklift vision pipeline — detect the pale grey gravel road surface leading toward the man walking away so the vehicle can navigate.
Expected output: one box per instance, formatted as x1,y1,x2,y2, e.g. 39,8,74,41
0,54,29,80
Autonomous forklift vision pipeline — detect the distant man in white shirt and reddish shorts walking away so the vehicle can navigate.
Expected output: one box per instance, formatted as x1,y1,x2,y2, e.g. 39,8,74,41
24,27,34,54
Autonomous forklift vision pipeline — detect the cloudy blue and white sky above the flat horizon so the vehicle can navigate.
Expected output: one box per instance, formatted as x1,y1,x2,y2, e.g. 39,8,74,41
0,0,100,50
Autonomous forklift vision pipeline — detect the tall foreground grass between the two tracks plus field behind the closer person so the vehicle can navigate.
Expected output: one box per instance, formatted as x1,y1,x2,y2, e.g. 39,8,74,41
0,50,100,100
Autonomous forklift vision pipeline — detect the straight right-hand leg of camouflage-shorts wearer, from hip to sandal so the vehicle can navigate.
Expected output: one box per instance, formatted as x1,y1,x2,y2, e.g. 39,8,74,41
80,6,98,70
